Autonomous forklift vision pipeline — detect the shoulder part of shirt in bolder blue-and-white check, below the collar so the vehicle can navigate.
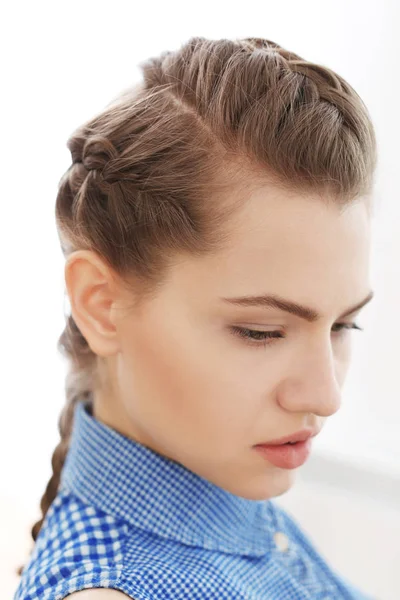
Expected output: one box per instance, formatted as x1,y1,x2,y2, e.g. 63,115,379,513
15,490,129,600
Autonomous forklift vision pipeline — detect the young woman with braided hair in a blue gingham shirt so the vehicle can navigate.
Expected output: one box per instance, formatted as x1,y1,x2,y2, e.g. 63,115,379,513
15,37,376,600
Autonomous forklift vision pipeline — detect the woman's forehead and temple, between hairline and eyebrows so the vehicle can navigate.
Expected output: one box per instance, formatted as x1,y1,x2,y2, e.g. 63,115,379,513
167,186,370,312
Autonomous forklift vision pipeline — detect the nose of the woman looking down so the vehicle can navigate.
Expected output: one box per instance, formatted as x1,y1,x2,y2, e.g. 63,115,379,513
278,342,341,417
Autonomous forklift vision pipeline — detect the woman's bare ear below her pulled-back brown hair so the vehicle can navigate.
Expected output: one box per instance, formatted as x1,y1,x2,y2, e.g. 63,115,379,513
64,250,119,357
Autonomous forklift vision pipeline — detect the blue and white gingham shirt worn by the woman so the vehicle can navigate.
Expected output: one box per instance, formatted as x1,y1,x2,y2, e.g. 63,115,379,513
14,401,374,600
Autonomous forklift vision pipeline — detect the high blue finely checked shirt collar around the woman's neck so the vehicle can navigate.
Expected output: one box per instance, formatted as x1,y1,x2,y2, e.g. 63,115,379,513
60,401,276,556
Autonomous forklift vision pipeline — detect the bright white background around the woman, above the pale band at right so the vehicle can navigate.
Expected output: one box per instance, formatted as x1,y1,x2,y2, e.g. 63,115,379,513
0,0,400,596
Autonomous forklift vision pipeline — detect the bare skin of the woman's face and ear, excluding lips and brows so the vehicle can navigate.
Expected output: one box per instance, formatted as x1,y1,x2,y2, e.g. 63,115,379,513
65,184,371,500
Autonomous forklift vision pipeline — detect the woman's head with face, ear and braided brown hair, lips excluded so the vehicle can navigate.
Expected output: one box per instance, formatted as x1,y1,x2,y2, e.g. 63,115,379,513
20,38,376,572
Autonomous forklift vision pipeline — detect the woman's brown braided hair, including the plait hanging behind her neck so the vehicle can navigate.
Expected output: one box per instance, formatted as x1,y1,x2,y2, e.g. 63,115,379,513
18,37,376,574
